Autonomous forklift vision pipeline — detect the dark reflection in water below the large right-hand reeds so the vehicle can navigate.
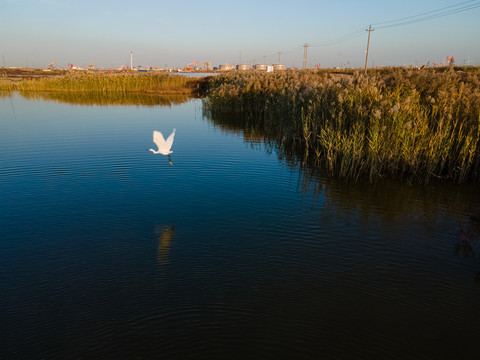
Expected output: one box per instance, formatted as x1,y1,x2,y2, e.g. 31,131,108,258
204,104,480,278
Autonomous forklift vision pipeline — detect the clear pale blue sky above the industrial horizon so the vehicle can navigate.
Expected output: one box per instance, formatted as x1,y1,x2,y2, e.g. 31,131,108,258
0,0,480,68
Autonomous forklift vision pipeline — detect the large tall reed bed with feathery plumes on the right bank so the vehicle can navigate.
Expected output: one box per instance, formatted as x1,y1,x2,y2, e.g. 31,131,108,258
204,68,480,183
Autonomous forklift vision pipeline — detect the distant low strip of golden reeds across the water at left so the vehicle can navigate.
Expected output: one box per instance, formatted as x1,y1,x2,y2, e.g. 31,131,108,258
15,73,197,94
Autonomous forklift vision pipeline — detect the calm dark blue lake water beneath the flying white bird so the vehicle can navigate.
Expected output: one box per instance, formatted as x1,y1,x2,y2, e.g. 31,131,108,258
0,95,480,359
